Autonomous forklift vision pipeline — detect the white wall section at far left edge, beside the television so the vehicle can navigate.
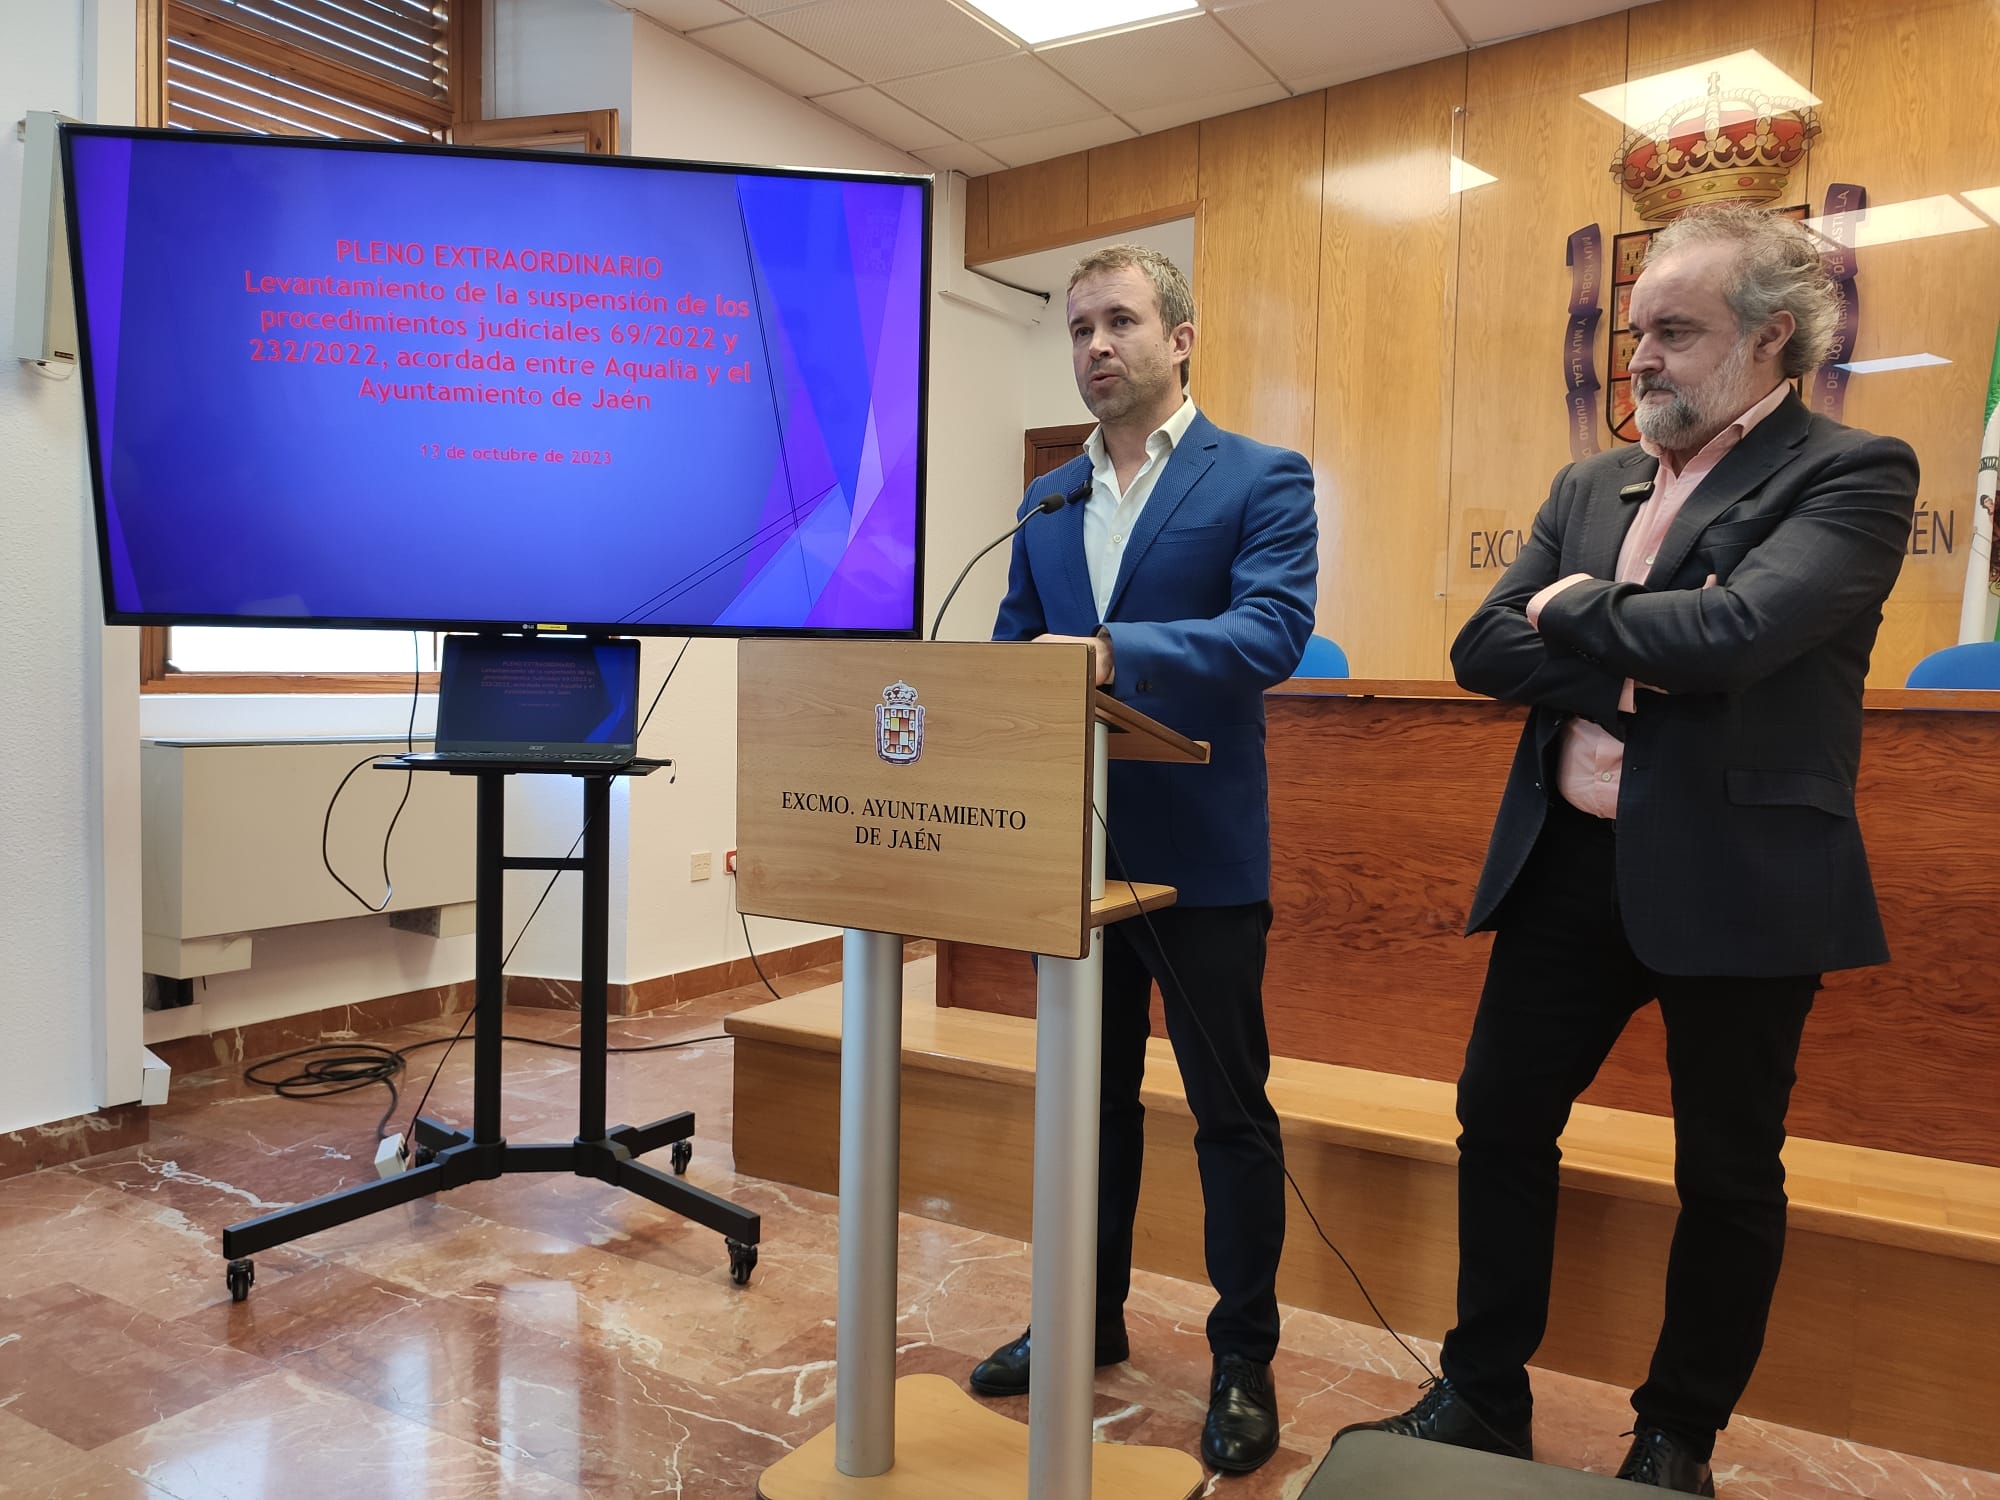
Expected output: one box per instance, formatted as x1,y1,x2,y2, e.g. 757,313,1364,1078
0,0,140,1130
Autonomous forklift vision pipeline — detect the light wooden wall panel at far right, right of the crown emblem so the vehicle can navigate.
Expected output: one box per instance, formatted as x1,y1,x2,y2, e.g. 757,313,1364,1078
1806,0,2000,688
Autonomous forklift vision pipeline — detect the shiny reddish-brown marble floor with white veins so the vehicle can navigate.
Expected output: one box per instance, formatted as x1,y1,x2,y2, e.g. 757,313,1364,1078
0,970,2000,1500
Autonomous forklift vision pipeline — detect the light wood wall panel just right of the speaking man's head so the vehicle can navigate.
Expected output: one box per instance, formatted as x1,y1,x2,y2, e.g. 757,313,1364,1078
1194,94,1326,456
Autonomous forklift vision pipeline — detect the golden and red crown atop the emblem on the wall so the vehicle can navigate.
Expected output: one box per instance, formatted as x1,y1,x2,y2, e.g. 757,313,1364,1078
1612,72,1820,224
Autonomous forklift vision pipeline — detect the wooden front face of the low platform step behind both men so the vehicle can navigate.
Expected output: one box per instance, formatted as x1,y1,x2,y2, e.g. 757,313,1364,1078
732,992,2000,1472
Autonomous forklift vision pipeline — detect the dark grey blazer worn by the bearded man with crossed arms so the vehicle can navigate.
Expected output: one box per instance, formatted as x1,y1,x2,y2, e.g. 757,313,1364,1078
1452,396,1916,978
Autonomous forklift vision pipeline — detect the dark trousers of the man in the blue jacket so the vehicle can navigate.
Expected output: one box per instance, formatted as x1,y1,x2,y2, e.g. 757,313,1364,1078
1098,902,1284,1362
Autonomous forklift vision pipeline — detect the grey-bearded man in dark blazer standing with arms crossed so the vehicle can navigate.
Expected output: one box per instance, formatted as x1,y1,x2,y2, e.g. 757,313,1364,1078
1364,208,1916,1494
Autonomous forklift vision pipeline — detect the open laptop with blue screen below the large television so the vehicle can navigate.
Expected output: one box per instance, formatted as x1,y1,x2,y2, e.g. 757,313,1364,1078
396,636,638,770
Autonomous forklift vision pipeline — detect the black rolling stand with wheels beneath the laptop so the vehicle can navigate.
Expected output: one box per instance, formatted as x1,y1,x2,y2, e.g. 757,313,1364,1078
222,760,760,1302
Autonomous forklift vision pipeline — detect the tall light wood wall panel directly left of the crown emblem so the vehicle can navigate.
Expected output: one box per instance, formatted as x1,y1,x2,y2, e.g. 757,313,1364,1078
1436,14,1626,676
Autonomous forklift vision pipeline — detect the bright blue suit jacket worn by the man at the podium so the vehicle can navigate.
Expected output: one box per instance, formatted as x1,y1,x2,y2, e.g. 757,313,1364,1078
994,414,1320,906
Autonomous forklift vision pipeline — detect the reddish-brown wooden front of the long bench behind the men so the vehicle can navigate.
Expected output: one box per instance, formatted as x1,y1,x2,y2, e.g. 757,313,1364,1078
938,694,2000,1166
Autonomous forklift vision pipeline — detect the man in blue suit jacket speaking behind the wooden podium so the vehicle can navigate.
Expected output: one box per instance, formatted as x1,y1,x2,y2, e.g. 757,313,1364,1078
972,246,1318,1472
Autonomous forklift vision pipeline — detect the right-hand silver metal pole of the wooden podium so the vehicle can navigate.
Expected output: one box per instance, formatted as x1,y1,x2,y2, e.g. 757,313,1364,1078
1028,722,1106,1500
